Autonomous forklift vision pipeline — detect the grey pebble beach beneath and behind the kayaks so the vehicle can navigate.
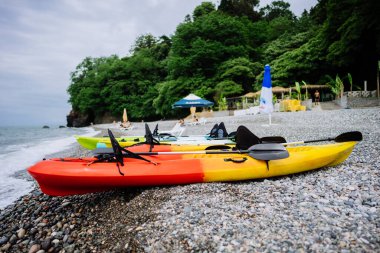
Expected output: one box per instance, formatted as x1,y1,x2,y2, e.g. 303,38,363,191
0,107,380,253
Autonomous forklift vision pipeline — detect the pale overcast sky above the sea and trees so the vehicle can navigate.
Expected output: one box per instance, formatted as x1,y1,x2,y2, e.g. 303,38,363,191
0,0,317,126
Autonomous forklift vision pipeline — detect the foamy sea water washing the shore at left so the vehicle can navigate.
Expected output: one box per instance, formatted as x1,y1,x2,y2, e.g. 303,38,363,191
0,126,98,209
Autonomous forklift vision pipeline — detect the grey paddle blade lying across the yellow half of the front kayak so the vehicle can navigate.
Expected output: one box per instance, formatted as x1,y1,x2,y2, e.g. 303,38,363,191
248,143,289,161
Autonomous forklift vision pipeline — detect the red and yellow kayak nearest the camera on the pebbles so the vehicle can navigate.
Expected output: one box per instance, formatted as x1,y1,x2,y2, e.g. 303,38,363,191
28,141,357,196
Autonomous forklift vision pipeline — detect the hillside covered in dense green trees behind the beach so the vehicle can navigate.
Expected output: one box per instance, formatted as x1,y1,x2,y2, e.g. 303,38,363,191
68,0,380,122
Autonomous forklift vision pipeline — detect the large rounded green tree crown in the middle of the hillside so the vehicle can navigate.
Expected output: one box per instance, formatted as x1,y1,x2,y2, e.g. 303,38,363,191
168,12,248,79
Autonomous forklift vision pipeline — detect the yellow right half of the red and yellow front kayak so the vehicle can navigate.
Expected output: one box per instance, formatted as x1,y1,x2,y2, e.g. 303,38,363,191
191,142,357,182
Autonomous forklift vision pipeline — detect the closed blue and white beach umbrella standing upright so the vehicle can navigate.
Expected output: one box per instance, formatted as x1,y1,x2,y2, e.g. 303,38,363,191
259,64,273,114
